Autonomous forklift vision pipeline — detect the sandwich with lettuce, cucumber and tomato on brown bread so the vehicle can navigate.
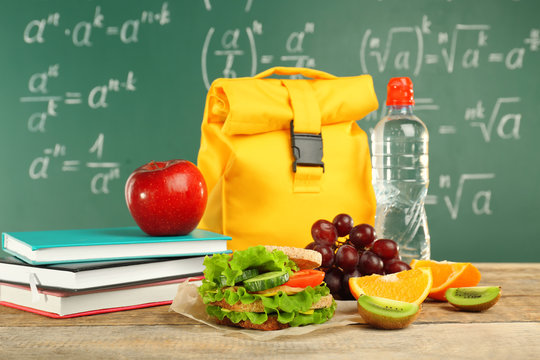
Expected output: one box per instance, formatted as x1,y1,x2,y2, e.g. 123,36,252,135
199,245,336,330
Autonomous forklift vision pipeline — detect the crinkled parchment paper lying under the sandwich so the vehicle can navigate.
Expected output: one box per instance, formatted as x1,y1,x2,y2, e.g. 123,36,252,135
169,282,364,340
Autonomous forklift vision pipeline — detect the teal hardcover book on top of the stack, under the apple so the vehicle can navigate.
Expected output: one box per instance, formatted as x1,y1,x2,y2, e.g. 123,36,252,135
2,227,231,265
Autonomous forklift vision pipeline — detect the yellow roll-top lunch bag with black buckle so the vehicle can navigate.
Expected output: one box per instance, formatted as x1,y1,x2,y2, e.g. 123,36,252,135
197,67,378,250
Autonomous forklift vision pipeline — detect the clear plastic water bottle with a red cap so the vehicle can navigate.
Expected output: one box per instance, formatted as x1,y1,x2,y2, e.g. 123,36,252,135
371,77,430,263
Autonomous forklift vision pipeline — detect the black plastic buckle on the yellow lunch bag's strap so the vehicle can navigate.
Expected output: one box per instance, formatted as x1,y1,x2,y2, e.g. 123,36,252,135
291,121,324,172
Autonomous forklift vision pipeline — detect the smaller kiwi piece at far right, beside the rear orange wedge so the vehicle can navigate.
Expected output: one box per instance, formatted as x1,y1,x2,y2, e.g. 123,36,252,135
445,286,501,311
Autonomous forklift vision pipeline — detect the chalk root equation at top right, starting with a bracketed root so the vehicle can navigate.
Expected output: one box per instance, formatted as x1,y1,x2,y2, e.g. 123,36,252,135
360,15,540,76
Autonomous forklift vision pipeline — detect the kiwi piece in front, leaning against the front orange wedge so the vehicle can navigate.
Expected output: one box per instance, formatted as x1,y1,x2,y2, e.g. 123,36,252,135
358,295,420,329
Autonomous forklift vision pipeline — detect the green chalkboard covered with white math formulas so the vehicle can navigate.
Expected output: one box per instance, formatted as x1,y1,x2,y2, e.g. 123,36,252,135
0,0,540,261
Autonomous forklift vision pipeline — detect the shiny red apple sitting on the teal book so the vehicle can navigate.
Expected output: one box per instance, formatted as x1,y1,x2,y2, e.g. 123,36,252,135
125,160,208,236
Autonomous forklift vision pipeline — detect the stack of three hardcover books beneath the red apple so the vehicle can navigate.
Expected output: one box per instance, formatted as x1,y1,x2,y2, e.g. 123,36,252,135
0,227,230,318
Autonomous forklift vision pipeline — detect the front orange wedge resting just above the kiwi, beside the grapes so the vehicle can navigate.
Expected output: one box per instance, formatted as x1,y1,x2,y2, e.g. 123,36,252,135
349,268,433,305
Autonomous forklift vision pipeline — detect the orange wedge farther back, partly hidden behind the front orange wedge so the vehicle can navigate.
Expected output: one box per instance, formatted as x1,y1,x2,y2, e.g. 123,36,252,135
411,260,481,301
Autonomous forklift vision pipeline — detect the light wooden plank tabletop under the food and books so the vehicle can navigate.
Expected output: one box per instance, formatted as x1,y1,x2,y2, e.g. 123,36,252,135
0,263,540,360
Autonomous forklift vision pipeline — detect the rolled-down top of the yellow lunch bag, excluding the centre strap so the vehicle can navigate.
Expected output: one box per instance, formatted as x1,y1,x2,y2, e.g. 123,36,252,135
207,67,378,135
